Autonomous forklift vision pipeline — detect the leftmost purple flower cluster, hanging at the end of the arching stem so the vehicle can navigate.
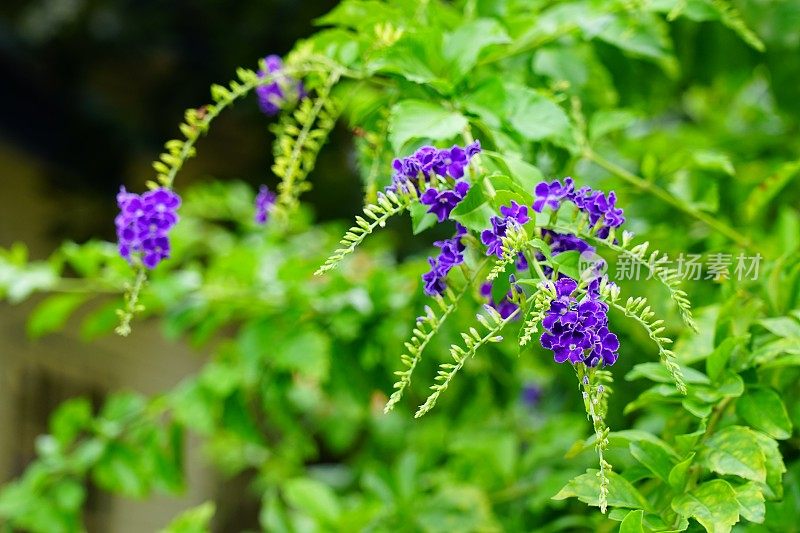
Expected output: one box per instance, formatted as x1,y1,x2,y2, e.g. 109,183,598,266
114,187,181,269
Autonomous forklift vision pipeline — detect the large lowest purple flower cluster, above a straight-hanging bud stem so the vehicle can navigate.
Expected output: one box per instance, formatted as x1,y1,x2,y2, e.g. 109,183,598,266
539,277,619,366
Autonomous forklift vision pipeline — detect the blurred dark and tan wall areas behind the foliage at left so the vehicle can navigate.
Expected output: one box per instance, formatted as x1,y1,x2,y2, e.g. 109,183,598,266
0,0,344,533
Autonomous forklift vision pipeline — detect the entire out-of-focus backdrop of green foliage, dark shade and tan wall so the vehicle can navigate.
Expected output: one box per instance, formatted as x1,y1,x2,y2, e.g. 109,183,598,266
0,0,800,532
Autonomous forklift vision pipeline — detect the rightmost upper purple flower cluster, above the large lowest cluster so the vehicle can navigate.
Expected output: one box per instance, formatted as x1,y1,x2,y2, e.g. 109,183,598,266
533,178,625,238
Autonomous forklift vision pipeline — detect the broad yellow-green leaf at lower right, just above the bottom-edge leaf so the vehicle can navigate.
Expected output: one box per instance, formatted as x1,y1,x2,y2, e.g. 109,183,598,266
701,426,767,483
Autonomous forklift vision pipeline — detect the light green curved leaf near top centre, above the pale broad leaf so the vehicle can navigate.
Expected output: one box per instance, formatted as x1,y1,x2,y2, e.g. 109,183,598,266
444,19,511,79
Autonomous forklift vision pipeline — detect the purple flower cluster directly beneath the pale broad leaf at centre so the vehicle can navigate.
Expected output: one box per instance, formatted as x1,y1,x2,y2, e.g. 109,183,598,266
386,141,481,193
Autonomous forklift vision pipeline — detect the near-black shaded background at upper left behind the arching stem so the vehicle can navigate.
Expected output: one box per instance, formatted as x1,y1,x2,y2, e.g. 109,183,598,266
0,0,361,245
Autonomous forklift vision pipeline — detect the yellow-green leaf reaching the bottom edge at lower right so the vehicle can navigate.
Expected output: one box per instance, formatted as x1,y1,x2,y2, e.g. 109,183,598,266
672,479,739,533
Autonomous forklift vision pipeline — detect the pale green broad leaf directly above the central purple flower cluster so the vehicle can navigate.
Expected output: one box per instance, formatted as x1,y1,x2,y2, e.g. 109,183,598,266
389,100,467,153
